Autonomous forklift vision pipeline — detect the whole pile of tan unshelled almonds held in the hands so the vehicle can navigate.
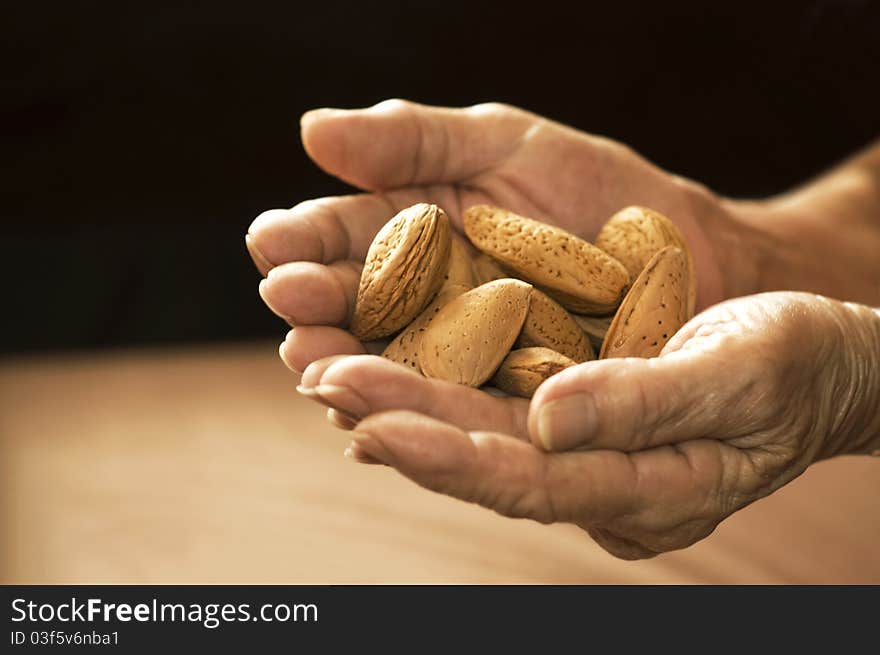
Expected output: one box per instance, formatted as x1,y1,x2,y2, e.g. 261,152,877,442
350,203,696,398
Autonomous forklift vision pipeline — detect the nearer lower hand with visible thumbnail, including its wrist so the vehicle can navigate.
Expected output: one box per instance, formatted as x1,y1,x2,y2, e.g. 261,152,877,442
302,293,880,559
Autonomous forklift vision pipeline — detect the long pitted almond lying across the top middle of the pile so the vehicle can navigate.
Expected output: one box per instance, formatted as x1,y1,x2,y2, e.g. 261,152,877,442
463,205,629,315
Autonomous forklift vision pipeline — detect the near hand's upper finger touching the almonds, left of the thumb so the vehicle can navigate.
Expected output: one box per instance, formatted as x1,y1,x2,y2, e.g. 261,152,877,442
301,356,528,439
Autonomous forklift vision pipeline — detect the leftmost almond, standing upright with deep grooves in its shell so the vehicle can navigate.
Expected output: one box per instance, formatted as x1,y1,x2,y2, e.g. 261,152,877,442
349,203,452,341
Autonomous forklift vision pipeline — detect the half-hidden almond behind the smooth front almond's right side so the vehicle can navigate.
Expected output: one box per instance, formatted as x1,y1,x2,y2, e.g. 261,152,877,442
513,289,595,363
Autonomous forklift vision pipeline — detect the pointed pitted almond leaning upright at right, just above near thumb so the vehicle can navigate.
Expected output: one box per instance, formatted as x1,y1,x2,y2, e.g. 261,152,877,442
599,246,688,359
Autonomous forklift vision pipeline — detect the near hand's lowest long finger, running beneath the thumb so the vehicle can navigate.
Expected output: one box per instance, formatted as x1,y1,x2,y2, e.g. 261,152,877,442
353,411,642,524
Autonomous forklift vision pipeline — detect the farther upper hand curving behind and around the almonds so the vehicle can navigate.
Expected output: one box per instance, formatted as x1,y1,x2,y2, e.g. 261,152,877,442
247,100,750,371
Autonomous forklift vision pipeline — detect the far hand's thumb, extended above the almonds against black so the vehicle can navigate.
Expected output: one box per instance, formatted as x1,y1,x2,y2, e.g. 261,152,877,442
301,100,536,190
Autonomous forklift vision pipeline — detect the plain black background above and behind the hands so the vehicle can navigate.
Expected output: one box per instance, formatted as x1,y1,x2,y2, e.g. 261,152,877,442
0,0,880,353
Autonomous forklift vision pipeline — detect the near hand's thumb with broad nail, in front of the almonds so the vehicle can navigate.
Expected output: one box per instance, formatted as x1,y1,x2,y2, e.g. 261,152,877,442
528,349,753,451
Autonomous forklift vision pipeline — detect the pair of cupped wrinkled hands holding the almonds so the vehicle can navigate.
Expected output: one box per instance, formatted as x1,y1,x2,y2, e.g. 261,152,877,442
246,100,876,559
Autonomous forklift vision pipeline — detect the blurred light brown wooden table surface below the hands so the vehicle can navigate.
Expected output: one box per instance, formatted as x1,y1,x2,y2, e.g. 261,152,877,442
0,343,880,584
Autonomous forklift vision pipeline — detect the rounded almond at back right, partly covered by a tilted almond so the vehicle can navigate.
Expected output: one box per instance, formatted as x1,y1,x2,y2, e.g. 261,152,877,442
596,206,697,316
